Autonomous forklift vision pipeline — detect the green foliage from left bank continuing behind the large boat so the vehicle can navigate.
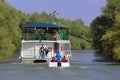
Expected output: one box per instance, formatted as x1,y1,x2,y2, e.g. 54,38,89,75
0,0,92,60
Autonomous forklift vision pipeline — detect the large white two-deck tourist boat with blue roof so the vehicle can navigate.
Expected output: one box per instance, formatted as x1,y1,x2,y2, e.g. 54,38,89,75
20,23,71,67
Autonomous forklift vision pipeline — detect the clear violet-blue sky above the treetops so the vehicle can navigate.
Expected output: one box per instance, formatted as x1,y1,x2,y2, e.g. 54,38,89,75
5,0,107,26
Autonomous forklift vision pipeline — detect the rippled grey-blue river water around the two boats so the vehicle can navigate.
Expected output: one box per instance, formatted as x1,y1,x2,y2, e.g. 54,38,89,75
0,50,120,80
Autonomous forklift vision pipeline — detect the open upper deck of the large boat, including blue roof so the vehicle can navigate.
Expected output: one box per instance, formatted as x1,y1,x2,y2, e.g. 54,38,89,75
23,23,69,41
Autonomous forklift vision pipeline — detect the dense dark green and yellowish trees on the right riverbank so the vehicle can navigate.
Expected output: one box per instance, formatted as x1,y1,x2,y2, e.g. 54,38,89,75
91,0,120,61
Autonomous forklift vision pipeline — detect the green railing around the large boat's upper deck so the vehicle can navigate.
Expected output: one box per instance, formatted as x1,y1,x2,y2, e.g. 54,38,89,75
23,33,68,41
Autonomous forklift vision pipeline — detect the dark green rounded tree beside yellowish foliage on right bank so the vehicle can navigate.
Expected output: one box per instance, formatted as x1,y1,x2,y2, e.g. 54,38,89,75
91,16,113,51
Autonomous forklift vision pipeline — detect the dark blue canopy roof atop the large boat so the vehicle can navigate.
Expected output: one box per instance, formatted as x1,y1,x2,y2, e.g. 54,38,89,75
23,23,67,29
